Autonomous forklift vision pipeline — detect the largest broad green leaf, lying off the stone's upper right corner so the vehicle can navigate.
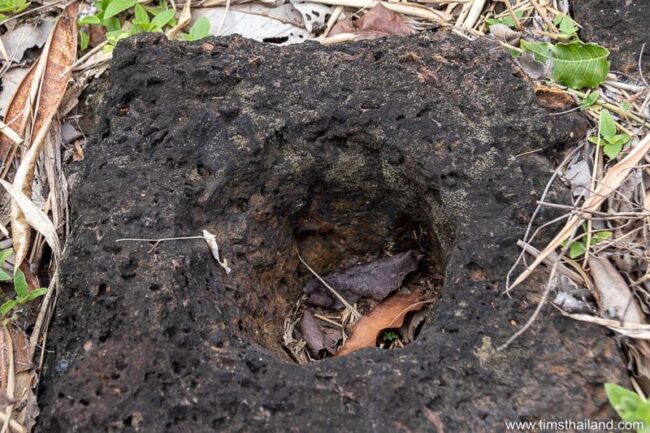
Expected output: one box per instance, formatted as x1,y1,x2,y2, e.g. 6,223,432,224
521,39,609,89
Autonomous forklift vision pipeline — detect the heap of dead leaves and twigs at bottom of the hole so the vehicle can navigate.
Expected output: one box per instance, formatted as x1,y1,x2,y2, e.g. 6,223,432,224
283,250,434,364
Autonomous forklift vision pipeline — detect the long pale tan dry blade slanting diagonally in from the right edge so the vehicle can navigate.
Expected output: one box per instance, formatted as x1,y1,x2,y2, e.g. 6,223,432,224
508,134,650,290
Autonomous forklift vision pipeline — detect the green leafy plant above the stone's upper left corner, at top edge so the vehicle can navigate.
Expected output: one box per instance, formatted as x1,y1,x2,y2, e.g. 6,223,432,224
79,0,176,52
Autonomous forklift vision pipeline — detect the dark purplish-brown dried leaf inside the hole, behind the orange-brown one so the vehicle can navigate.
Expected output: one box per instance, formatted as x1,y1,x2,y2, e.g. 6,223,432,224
303,251,420,308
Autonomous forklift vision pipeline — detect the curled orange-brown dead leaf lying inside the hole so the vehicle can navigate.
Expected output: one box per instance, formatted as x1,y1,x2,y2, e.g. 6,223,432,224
336,292,433,356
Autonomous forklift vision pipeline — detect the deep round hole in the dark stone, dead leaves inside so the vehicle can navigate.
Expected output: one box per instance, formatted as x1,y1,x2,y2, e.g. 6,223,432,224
218,176,445,364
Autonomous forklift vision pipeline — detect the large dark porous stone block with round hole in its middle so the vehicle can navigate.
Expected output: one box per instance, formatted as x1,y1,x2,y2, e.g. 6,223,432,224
39,32,625,433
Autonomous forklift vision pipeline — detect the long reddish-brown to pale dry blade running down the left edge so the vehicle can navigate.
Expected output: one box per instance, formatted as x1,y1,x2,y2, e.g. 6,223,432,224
5,3,79,274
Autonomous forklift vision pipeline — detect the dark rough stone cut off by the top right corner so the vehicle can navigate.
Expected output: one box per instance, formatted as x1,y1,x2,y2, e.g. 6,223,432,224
571,0,650,74
